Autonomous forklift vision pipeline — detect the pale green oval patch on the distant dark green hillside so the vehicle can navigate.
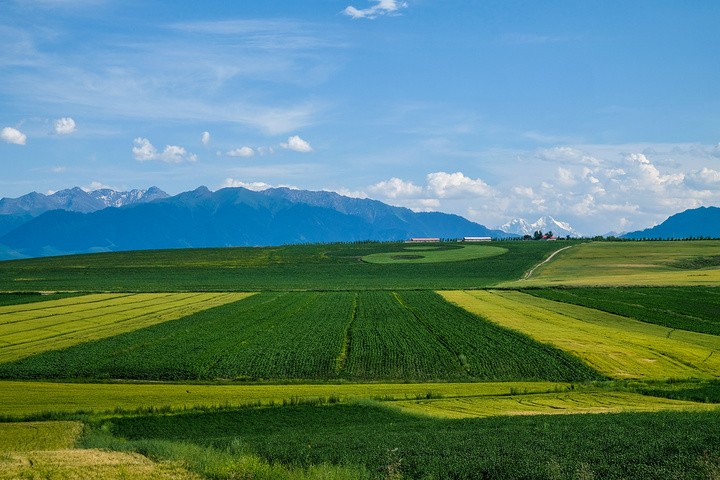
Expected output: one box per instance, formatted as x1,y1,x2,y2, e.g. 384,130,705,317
362,245,508,264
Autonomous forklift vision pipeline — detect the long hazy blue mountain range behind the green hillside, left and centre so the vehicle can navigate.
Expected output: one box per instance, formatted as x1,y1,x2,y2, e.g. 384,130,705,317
0,187,511,258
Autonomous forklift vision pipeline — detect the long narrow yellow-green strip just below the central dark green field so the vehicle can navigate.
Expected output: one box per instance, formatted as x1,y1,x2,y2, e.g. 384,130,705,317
0,381,569,420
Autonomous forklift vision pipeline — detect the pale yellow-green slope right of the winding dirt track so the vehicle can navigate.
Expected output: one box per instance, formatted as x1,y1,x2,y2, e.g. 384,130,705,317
499,240,720,288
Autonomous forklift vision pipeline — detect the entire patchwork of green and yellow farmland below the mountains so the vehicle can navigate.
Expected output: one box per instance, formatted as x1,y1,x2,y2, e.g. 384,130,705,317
0,241,720,480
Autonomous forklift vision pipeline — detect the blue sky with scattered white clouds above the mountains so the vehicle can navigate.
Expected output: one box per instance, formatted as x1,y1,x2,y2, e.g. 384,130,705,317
0,0,720,235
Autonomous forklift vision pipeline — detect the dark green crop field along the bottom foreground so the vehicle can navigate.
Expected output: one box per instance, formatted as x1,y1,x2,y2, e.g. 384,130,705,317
97,403,720,480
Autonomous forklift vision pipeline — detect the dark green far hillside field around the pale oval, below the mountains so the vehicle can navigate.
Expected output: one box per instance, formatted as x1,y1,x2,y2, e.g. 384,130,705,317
0,241,558,292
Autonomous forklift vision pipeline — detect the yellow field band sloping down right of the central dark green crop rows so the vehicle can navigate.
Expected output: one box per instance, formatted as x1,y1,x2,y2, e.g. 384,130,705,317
440,291,720,379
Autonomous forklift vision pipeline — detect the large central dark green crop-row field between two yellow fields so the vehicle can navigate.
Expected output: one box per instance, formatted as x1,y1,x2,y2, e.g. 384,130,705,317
0,291,602,381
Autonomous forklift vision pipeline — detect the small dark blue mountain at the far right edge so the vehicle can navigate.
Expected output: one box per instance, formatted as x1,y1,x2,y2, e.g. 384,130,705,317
622,207,720,239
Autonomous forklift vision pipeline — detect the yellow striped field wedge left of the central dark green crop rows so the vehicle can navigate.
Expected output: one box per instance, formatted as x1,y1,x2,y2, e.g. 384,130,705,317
0,293,252,363
